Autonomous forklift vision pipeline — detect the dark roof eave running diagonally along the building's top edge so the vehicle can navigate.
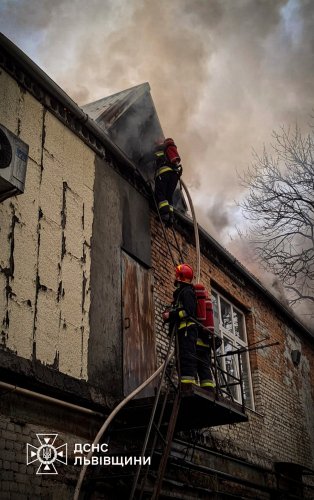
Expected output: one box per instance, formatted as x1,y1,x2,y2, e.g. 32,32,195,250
0,33,314,342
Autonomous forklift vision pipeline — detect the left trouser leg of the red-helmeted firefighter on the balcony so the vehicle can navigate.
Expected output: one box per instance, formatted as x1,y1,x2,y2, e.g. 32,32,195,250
178,325,197,384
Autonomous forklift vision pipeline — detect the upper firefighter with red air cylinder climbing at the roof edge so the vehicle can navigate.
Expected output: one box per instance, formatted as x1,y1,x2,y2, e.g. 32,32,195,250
154,137,182,226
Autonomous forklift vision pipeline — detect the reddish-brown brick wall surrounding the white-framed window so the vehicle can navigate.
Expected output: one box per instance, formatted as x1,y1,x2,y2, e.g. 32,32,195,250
152,216,314,468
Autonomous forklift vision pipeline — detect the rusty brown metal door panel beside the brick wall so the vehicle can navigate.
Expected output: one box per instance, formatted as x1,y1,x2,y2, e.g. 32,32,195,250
122,252,156,397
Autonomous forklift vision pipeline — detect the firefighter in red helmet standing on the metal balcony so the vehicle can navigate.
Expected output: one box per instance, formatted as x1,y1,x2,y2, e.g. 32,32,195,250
164,264,215,391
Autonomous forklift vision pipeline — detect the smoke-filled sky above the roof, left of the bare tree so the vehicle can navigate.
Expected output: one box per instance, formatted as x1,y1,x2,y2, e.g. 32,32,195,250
0,0,314,308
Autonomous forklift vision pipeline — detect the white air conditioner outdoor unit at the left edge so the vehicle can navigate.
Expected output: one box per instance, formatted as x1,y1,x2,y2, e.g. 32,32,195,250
0,125,28,202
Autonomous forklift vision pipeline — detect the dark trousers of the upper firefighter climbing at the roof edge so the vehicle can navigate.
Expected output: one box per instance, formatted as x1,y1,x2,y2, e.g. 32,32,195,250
155,169,178,219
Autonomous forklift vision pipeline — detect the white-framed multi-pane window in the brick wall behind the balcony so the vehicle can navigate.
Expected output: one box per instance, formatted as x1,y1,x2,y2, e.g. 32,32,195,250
212,290,254,409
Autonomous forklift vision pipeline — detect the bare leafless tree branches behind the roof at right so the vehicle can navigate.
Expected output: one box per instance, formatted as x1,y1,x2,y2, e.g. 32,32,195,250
240,127,314,317
